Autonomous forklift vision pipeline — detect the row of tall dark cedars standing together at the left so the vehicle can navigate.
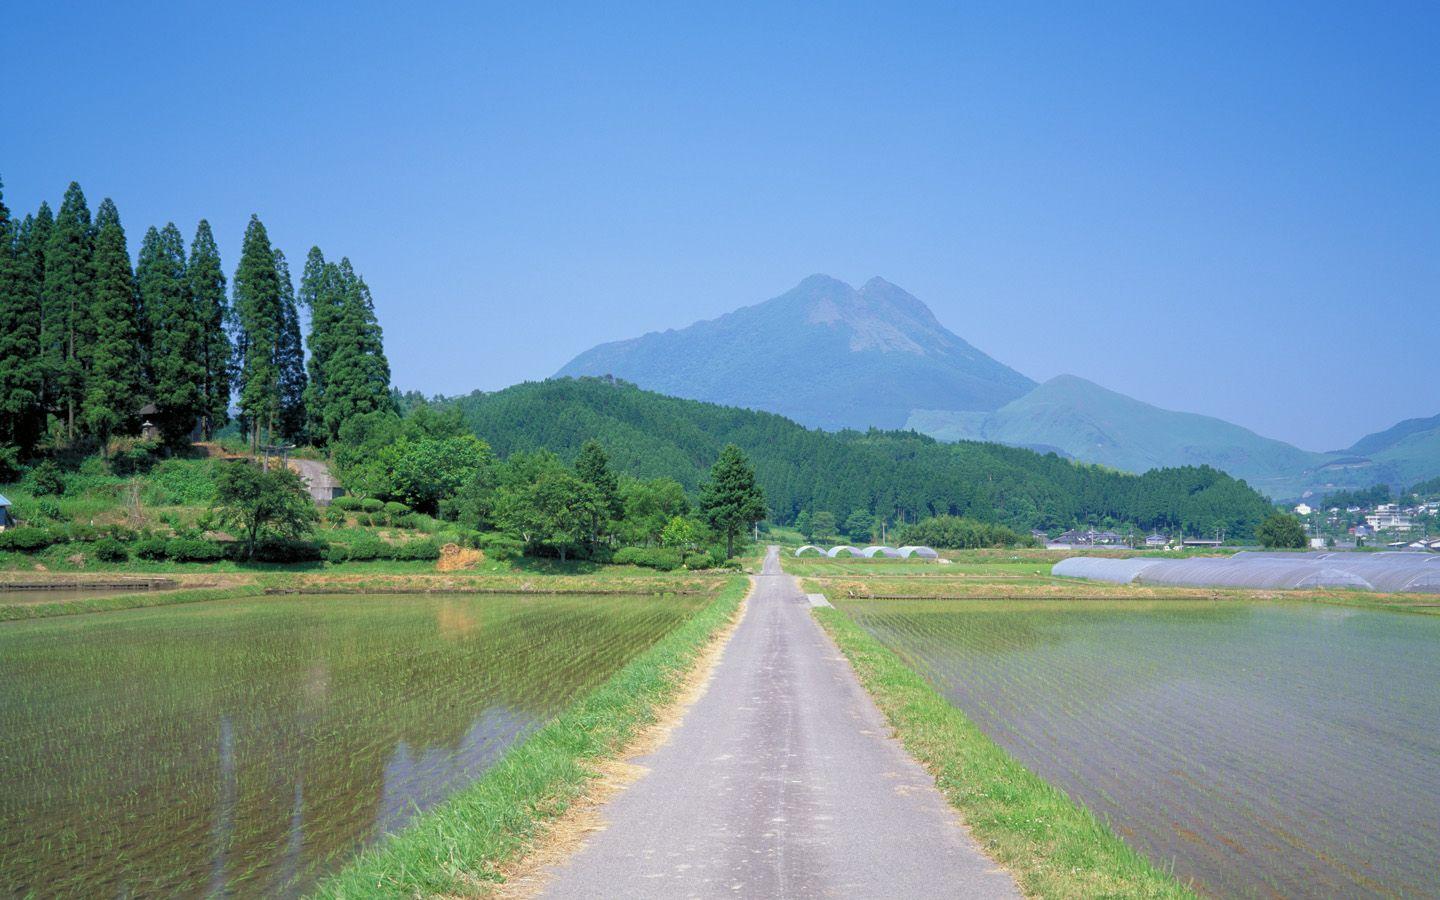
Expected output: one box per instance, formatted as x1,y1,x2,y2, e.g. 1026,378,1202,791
0,175,390,459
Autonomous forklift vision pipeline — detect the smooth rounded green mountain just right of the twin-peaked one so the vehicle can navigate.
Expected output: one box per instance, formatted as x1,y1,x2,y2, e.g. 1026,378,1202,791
906,374,1326,492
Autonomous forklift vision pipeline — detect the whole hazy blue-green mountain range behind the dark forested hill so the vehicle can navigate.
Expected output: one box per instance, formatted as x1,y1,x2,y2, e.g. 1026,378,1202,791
557,275,1440,498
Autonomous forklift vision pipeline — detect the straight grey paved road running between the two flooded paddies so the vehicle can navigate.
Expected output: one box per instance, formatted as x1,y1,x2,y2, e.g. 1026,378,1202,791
543,549,1020,899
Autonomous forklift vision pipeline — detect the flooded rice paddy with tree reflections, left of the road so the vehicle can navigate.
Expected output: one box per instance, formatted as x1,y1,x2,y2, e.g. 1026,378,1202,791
0,595,703,897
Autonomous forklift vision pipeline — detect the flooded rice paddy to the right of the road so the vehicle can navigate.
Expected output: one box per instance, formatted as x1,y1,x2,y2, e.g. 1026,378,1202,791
841,600,1440,897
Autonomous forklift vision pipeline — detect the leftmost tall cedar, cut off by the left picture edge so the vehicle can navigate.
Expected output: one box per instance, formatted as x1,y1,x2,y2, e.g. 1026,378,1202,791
0,183,40,455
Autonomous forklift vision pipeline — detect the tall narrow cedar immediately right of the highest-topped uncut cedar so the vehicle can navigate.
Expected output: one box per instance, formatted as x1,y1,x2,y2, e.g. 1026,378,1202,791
82,197,141,451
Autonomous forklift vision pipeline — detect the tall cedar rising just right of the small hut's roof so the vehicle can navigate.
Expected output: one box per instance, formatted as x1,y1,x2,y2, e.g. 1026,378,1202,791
138,222,206,448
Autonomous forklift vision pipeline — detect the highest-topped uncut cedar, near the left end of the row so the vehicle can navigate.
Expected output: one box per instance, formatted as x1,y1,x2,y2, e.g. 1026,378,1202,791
40,181,95,439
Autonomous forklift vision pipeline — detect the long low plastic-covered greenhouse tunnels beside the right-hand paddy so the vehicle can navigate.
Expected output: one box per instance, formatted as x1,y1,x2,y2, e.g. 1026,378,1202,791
1051,552,1440,593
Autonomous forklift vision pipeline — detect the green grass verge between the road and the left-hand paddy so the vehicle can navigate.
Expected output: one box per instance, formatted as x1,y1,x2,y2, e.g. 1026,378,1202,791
314,577,749,899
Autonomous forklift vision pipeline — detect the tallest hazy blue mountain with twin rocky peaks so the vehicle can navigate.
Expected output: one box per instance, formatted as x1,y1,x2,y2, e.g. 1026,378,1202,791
557,275,1034,429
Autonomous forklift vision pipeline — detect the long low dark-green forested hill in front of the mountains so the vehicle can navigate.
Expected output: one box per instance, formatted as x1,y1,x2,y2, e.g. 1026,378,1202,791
441,377,1270,536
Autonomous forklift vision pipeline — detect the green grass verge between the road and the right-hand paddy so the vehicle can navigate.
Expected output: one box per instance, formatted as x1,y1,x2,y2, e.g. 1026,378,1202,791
815,609,1194,899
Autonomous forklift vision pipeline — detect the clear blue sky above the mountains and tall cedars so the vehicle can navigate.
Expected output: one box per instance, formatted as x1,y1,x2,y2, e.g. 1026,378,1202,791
0,1,1440,449
